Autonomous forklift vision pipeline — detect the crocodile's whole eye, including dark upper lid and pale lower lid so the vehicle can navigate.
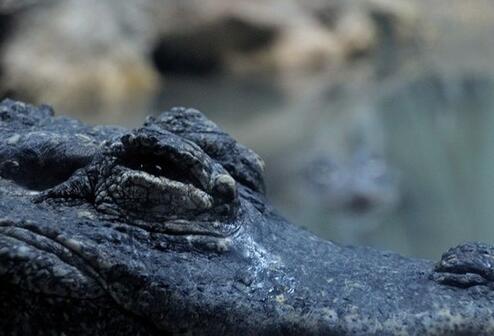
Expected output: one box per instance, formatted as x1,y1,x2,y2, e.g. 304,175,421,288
95,129,240,226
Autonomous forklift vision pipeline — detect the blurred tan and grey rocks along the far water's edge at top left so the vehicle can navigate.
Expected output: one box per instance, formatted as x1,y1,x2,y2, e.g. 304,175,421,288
0,0,416,110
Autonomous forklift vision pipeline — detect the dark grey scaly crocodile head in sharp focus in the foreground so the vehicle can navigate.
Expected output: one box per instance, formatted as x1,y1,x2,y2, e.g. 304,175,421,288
0,100,494,335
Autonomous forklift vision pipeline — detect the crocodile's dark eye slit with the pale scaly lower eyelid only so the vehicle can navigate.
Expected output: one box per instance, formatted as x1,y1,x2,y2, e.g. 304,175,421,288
95,153,213,219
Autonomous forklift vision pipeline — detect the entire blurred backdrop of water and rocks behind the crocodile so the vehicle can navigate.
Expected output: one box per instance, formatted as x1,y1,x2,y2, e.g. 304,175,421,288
0,0,494,259
